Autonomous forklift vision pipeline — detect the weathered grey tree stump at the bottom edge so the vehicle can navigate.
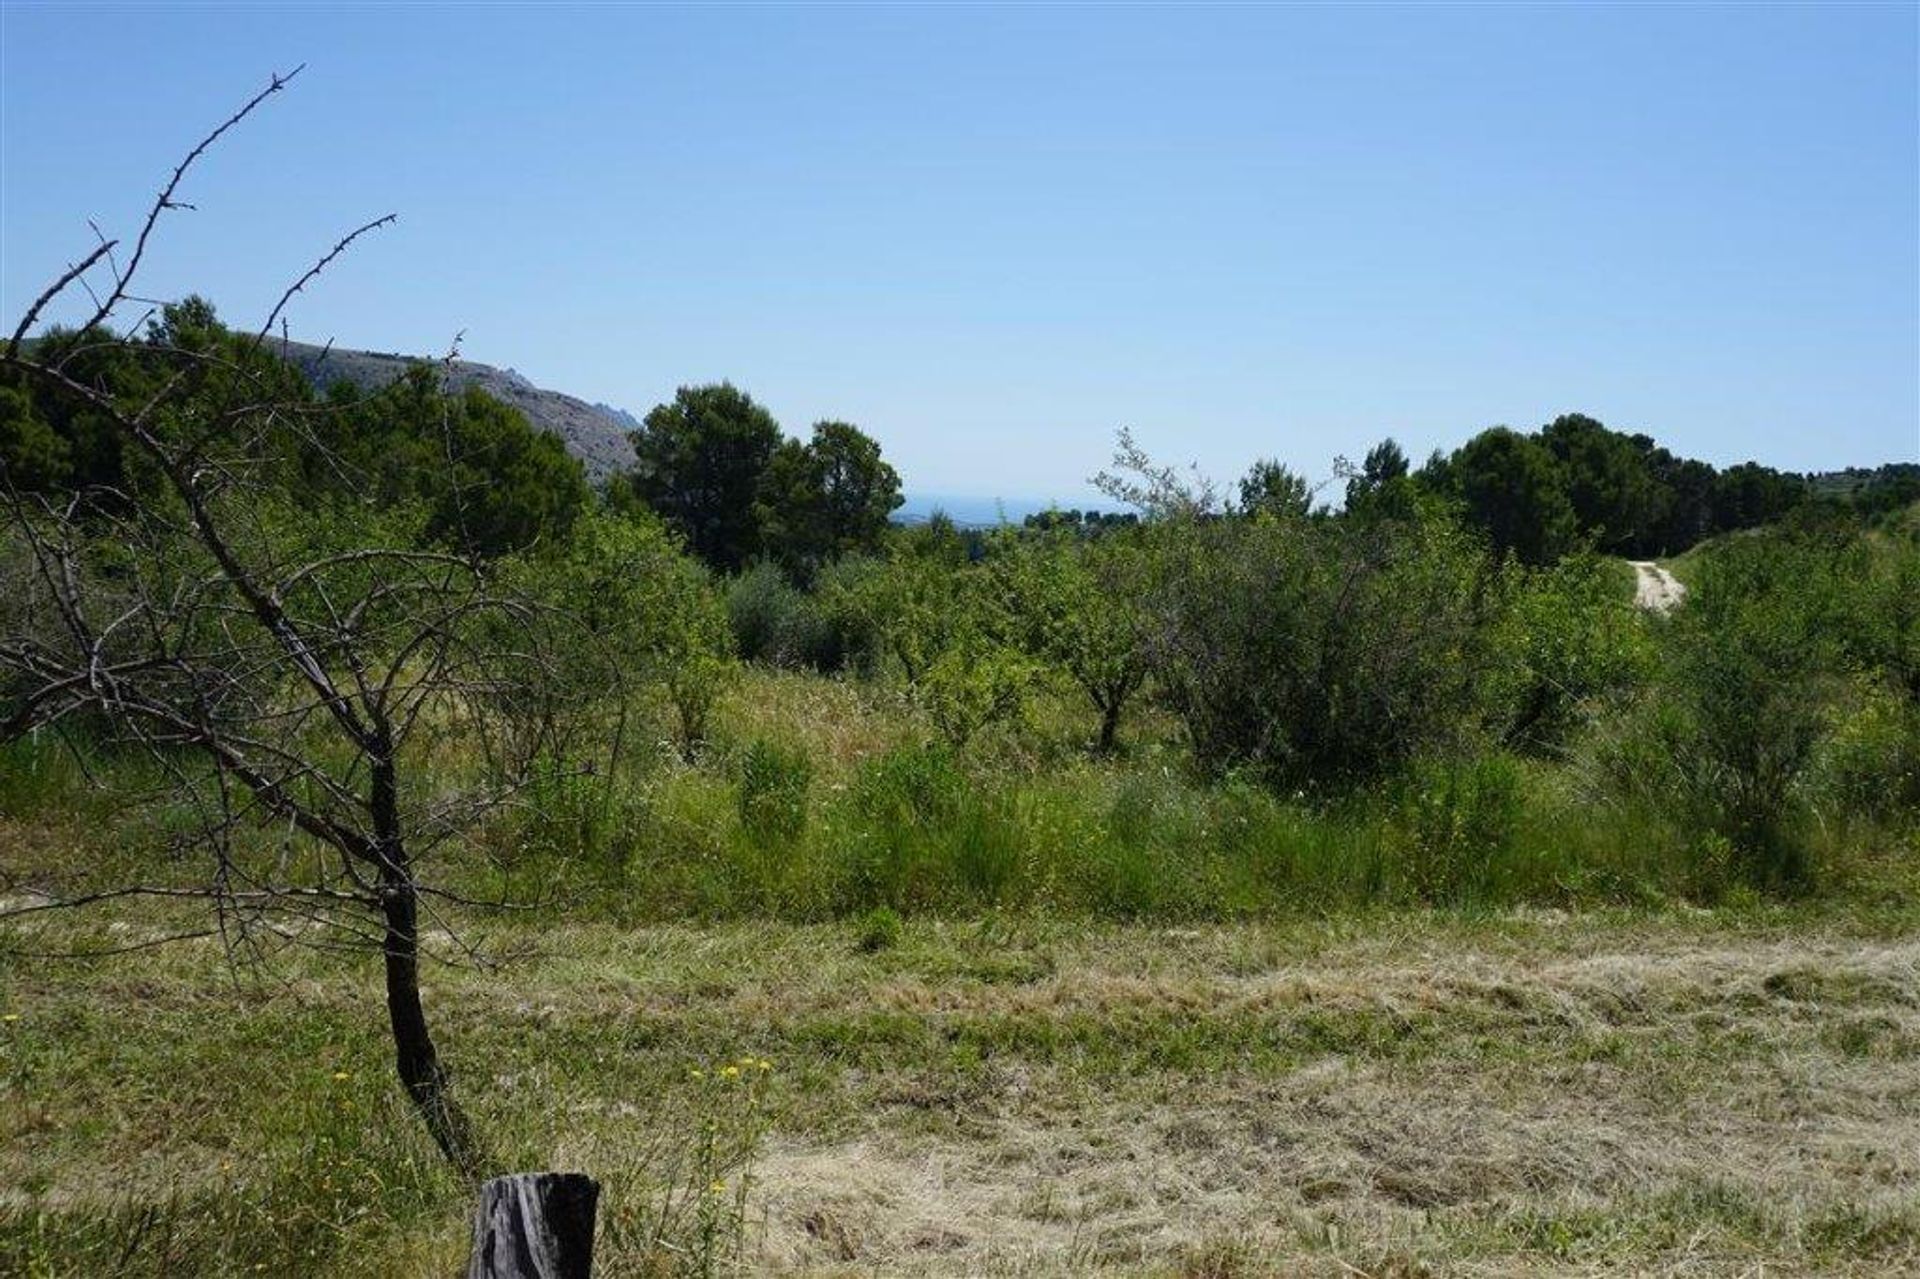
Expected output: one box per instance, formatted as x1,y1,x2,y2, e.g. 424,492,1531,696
467,1173,599,1279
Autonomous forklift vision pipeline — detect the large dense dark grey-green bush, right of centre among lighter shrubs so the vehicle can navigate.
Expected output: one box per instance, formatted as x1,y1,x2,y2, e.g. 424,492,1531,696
1150,499,1505,789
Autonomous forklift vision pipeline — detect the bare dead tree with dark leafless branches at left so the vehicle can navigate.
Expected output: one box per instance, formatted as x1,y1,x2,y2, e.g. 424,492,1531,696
0,67,612,1175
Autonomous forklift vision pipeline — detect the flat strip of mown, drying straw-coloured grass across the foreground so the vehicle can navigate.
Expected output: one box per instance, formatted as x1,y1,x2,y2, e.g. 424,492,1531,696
0,891,1920,1275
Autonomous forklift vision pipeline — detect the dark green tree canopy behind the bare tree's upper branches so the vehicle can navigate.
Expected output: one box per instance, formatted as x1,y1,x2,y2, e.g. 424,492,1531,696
0,298,591,557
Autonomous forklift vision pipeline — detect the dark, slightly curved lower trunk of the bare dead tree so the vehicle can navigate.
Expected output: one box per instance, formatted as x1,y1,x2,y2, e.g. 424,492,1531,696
372,759,482,1177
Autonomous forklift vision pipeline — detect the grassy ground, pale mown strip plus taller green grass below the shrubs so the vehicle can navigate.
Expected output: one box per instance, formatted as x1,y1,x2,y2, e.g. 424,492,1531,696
11,656,1920,1279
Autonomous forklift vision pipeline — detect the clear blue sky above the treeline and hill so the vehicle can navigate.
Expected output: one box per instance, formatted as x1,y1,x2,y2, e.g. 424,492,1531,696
0,0,1920,501
